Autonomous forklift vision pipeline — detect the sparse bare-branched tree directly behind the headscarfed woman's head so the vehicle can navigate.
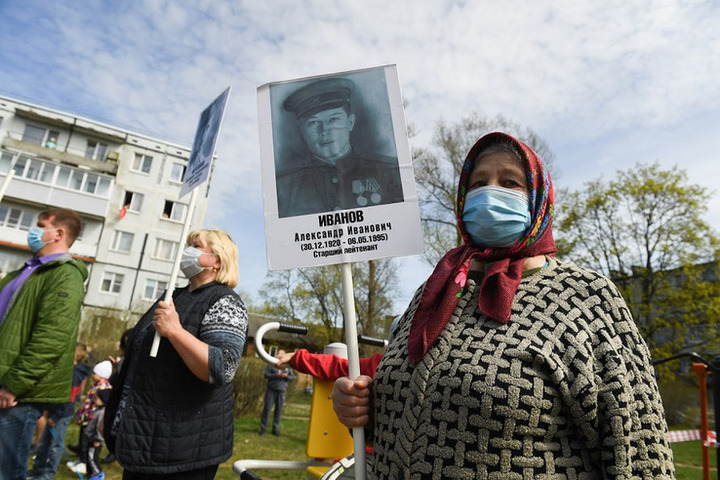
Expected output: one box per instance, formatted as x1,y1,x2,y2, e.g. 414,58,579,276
413,112,555,265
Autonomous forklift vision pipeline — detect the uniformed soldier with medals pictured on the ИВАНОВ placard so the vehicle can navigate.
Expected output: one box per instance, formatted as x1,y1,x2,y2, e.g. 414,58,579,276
277,78,403,218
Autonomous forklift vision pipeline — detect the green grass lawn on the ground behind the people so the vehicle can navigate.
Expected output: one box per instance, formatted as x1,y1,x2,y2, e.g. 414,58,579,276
43,404,718,480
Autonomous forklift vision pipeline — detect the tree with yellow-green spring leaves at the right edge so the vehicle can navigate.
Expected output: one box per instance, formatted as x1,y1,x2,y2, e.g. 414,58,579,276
556,163,720,374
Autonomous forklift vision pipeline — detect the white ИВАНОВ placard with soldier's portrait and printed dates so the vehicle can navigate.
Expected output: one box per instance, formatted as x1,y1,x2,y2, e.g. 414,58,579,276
258,65,423,270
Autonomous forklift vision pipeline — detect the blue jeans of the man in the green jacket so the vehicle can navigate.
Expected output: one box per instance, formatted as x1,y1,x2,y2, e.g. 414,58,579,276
0,403,46,480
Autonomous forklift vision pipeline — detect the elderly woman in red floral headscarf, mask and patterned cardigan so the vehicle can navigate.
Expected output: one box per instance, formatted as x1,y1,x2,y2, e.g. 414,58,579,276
333,133,674,479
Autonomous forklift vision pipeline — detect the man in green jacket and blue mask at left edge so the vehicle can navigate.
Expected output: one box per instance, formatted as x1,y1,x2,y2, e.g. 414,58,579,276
0,208,87,480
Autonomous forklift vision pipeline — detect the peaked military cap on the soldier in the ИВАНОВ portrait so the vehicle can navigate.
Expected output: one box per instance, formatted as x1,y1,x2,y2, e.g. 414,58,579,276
283,78,355,118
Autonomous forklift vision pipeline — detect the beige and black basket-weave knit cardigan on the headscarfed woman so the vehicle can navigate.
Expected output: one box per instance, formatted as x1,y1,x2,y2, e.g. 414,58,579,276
368,259,674,480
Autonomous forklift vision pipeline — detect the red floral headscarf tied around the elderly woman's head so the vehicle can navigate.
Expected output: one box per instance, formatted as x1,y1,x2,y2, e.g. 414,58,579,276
408,132,555,364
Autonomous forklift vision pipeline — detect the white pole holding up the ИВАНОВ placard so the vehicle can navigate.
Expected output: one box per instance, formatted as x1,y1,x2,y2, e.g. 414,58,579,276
340,263,366,480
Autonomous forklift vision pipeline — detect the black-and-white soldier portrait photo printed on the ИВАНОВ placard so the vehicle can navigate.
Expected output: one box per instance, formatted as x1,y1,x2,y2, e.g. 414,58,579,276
270,70,403,218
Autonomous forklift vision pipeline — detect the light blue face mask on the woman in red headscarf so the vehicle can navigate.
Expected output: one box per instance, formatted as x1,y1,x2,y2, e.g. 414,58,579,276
462,186,531,248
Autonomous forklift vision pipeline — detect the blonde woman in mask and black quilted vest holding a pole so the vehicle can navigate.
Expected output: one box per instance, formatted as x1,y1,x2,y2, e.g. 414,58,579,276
105,230,248,480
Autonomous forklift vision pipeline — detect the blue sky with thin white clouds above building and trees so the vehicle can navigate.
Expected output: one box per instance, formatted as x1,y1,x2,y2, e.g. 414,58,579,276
0,0,720,313
